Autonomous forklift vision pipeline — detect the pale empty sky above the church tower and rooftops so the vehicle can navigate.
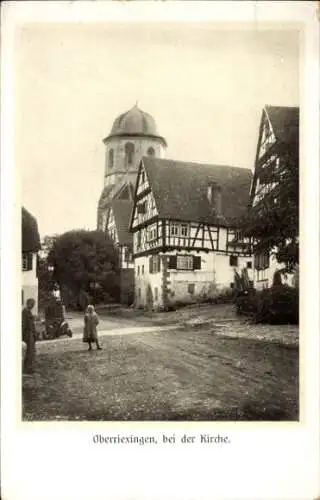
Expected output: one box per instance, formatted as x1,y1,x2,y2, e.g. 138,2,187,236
14,22,299,237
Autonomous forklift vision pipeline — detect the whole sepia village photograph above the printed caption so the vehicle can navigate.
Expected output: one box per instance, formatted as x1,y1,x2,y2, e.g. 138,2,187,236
19,21,300,422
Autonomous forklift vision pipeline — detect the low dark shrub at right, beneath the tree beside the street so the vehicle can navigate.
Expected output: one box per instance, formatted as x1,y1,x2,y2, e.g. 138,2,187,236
236,285,299,324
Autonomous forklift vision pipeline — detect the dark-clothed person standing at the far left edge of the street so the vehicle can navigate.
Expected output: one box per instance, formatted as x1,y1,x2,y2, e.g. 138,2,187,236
22,299,37,374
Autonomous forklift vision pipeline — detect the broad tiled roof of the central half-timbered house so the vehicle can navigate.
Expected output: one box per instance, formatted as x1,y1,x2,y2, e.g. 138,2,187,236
142,157,252,225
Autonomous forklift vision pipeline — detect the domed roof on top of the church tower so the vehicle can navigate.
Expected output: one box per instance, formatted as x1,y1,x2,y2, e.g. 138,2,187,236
104,104,166,145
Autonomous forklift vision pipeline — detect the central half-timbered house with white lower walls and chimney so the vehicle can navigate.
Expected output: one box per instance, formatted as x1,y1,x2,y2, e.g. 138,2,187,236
130,157,252,308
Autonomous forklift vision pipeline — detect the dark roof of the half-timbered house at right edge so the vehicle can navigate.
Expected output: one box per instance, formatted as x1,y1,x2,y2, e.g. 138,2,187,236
265,106,299,144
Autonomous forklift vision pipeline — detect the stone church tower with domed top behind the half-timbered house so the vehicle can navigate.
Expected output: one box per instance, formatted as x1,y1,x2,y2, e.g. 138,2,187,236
97,104,167,231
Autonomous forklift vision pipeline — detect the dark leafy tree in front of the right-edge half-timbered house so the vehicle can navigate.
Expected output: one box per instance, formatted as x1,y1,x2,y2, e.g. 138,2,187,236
240,150,299,270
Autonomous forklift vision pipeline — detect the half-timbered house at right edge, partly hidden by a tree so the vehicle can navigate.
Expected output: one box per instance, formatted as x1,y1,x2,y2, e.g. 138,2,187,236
249,106,299,289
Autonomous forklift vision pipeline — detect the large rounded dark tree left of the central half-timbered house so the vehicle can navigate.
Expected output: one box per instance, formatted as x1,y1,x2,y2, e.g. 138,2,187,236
48,230,118,306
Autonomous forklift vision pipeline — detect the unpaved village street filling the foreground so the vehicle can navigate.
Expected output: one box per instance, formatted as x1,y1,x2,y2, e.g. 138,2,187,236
23,306,299,420
